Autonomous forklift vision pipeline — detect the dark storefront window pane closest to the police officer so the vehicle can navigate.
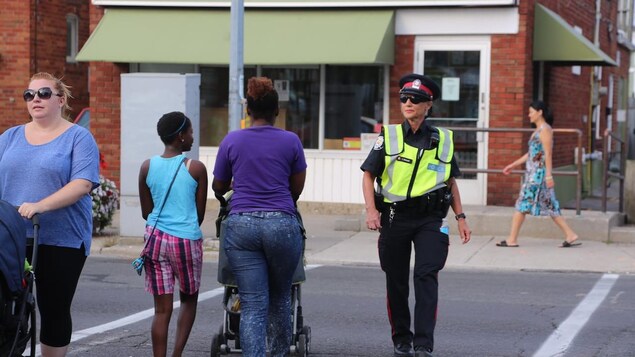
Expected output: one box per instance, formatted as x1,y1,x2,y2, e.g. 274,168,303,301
324,66,384,150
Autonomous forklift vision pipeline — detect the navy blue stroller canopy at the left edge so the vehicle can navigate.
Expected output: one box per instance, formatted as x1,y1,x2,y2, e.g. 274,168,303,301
0,200,26,294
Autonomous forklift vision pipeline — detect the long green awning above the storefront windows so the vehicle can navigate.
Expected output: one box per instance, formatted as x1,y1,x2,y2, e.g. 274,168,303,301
76,8,395,65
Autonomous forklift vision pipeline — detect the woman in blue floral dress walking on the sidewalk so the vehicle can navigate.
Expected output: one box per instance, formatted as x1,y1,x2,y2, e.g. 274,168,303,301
496,101,580,248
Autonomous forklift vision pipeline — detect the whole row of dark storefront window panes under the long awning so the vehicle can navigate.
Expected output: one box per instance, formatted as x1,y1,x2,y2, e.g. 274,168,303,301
138,64,384,150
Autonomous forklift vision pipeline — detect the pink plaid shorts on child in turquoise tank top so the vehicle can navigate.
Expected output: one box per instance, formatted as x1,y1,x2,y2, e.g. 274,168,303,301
144,226,203,295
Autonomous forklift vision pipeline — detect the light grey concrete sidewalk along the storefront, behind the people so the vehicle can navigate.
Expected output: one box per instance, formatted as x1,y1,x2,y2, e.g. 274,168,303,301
91,203,635,274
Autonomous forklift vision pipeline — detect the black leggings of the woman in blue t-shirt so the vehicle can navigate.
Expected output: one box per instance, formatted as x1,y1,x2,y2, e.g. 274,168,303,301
27,244,86,347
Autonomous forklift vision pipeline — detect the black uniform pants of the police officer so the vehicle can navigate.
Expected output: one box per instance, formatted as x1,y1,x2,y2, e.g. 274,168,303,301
378,212,449,349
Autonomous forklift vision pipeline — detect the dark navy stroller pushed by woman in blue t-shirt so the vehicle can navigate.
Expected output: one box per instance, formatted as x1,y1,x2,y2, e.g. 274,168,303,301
0,200,39,357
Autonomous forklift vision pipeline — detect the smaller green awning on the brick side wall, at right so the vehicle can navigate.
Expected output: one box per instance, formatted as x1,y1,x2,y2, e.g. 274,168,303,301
533,4,617,66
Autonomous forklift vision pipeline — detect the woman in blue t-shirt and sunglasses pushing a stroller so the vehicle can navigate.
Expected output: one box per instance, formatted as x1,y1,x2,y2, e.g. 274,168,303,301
0,73,99,357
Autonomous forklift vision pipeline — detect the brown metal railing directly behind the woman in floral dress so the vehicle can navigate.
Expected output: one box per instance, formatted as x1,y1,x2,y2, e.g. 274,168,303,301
446,127,584,216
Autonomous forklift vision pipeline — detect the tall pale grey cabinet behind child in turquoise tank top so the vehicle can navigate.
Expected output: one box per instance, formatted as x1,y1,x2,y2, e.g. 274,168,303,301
119,73,201,237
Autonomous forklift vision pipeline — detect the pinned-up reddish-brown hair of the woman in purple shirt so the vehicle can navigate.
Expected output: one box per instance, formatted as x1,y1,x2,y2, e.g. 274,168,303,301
247,77,278,123
